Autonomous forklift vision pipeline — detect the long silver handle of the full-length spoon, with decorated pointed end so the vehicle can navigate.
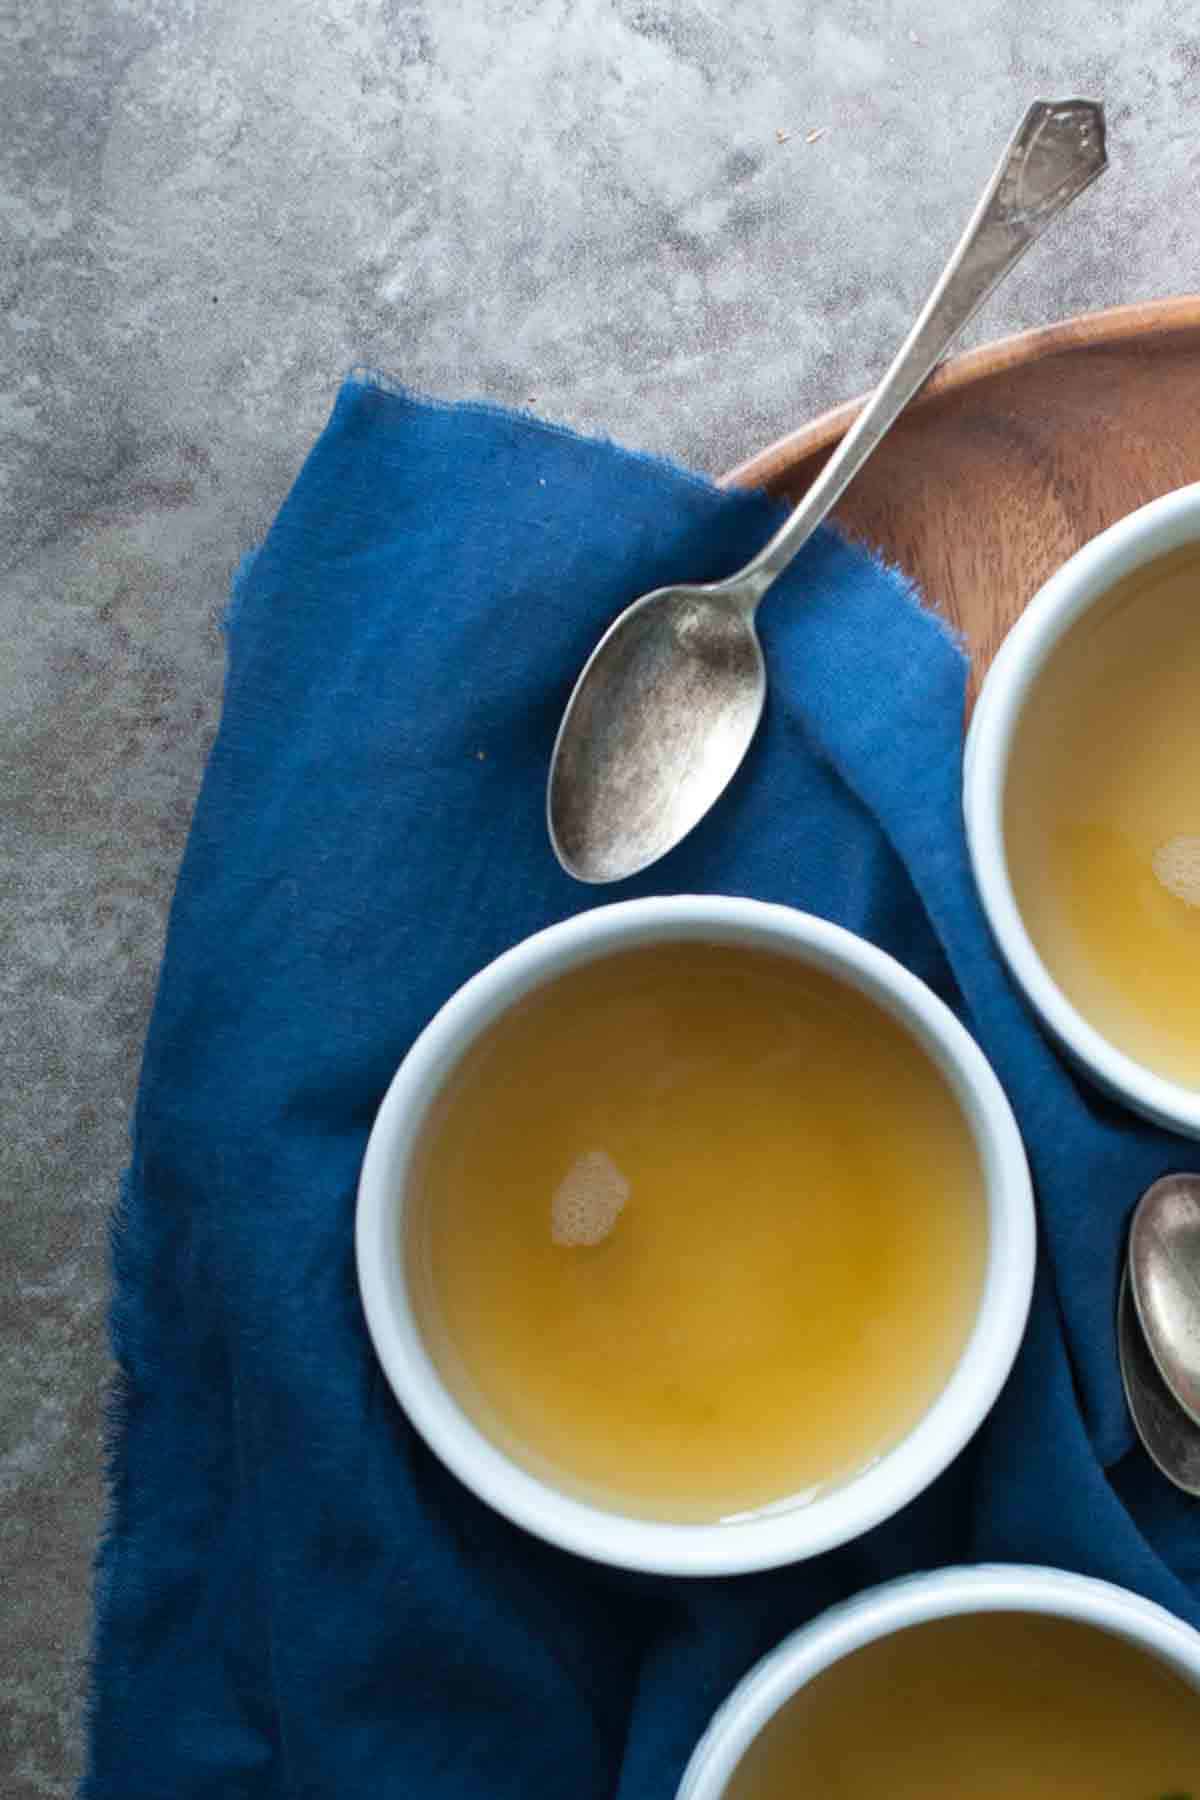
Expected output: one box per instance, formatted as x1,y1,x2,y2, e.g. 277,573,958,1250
734,101,1106,607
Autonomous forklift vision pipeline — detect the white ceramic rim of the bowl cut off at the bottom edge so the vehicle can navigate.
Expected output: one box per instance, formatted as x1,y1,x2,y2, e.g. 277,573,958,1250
676,1562,1200,1800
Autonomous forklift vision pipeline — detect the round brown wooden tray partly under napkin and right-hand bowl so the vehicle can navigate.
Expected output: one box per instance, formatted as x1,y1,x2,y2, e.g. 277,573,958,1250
723,295,1200,698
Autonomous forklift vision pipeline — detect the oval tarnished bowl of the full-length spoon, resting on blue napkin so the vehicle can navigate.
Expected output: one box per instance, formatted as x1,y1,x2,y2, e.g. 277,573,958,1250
547,583,766,882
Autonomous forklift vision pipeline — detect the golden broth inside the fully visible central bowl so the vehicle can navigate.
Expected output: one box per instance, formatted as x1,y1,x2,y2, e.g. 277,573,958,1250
407,943,986,1521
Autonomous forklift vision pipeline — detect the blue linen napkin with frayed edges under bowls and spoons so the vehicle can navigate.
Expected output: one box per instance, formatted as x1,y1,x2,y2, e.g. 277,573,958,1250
83,378,1200,1800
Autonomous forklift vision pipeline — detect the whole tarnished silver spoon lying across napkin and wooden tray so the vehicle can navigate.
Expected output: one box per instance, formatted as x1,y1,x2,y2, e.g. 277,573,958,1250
547,99,1105,882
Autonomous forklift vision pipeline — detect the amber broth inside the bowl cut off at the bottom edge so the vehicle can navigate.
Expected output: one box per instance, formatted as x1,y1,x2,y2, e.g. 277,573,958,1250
725,1613,1200,1800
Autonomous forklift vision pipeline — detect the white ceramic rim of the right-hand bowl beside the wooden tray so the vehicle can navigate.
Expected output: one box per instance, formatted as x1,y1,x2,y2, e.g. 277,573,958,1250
963,482,1200,1138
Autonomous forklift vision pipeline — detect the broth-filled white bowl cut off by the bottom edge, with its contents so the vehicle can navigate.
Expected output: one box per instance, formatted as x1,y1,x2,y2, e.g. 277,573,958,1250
676,1564,1200,1800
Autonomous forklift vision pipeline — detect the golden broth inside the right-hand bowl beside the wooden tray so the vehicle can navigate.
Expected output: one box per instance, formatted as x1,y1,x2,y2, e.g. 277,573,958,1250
1004,549,1200,1087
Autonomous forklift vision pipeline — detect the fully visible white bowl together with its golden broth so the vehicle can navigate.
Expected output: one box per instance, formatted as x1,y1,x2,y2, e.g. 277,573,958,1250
356,896,1034,1575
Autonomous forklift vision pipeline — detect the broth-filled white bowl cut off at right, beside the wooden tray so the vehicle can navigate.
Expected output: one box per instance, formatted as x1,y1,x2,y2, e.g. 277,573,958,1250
963,486,1200,1136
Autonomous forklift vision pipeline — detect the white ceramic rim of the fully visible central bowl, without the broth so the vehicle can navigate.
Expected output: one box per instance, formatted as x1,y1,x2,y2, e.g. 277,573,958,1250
356,896,1034,1575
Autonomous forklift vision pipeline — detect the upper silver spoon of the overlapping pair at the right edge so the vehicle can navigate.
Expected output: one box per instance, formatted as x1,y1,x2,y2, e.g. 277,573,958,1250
1130,1175,1200,1431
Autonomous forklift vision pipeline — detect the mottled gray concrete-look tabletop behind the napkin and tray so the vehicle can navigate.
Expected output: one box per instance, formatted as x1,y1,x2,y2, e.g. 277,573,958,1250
0,0,1200,1800
